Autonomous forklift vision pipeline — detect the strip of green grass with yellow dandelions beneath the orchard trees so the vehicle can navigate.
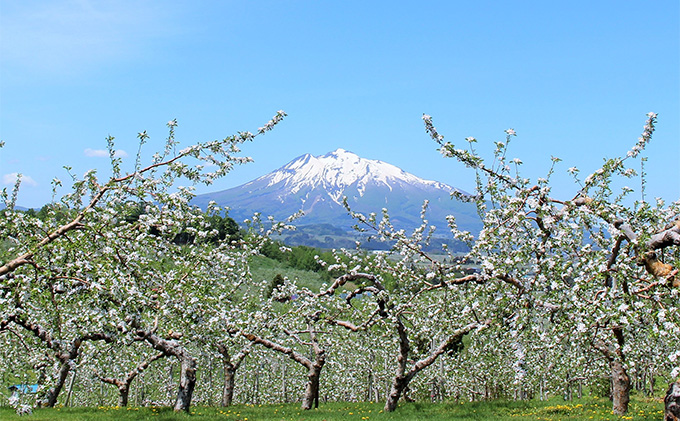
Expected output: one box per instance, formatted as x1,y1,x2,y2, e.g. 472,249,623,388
0,398,663,421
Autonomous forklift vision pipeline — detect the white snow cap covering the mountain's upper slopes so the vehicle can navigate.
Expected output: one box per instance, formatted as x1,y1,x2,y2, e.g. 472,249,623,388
260,148,453,203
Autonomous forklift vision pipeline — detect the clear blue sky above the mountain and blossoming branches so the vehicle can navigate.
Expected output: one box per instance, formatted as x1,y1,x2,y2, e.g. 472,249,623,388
0,0,680,206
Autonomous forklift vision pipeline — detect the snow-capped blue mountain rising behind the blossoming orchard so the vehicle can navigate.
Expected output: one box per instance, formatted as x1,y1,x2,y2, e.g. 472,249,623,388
193,149,480,231
